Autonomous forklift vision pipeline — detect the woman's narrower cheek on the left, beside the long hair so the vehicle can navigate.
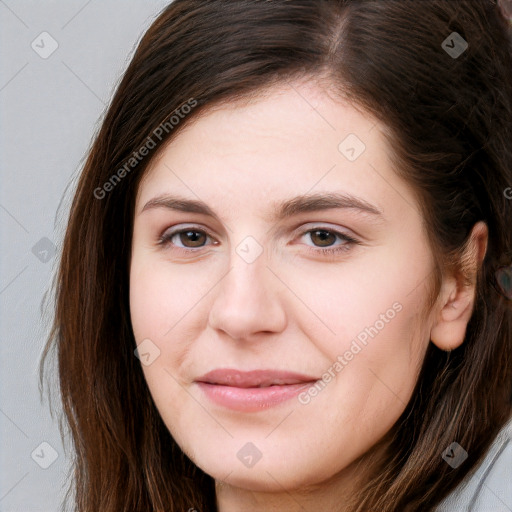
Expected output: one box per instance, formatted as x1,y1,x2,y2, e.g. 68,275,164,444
130,252,224,420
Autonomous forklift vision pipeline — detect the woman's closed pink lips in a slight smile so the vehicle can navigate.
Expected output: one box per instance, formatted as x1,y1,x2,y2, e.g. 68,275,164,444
195,369,318,412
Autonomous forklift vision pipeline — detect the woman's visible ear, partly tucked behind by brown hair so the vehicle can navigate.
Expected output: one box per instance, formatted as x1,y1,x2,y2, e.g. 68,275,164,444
430,221,489,351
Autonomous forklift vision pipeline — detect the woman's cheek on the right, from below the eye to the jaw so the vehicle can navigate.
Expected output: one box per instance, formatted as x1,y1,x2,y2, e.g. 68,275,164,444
288,237,431,420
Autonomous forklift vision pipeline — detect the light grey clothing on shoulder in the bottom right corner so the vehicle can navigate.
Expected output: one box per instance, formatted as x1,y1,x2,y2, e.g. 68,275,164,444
435,420,512,512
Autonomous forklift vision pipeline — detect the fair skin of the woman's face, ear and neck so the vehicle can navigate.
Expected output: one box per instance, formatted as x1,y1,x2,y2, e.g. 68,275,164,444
130,83,487,512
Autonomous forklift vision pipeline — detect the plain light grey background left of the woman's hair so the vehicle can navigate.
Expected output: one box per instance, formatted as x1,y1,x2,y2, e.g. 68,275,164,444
0,0,169,512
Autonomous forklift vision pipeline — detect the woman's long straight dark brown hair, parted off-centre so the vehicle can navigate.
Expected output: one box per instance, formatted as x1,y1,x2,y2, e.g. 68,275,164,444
41,0,512,512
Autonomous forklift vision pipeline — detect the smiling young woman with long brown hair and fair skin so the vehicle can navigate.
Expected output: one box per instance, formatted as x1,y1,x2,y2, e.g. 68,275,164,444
42,0,512,512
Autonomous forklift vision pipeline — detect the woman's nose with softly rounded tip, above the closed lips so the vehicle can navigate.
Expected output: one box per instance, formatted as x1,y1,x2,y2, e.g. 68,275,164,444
209,247,287,341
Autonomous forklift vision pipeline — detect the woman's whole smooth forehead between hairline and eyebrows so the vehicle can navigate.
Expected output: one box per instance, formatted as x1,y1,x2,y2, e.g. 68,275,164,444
137,83,414,222
